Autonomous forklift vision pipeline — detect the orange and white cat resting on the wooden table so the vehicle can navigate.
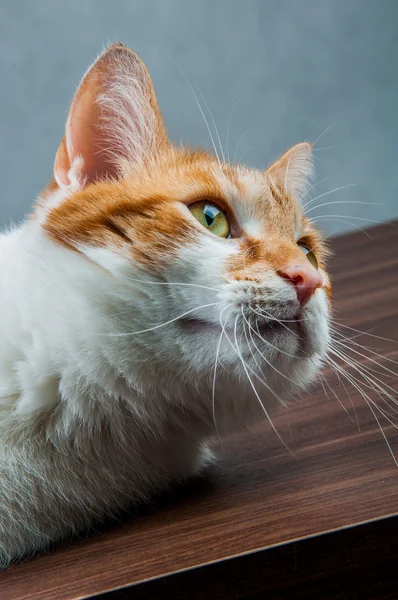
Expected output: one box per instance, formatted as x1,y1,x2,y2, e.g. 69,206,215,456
0,44,331,567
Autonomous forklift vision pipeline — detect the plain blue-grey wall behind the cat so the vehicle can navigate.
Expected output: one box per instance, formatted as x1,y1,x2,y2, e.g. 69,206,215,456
0,0,398,234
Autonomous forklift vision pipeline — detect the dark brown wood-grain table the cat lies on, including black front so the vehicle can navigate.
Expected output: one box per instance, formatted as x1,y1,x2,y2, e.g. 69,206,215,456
0,223,398,600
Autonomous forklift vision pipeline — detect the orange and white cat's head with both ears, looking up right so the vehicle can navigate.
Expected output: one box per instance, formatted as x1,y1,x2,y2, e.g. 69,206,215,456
42,45,330,432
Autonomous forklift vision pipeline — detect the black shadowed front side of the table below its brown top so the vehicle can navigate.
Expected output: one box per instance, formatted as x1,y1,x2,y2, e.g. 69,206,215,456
105,519,398,600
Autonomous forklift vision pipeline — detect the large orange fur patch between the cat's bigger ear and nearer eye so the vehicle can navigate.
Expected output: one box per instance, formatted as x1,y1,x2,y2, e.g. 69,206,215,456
44,148,233,267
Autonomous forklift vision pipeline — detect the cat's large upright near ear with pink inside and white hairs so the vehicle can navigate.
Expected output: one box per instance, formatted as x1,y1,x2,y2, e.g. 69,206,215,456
54,44,168,187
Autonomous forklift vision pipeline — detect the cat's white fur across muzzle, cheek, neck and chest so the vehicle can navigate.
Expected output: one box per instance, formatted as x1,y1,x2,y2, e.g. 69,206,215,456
0,176,328,565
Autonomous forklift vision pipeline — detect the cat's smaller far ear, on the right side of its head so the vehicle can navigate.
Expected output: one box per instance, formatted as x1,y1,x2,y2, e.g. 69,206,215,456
265,142,313,199
